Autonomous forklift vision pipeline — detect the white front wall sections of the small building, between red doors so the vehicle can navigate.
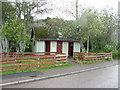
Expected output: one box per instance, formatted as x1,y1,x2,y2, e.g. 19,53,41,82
33,41,80,55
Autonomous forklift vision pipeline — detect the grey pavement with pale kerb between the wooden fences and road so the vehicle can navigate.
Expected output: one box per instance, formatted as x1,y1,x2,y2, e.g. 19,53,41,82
0,60,118,86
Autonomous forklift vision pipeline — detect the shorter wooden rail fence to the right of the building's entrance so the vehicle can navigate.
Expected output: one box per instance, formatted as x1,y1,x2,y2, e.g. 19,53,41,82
74,52,112,60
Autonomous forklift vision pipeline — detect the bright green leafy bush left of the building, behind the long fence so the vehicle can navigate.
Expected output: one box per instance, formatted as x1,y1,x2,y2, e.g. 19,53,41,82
2,19,29,51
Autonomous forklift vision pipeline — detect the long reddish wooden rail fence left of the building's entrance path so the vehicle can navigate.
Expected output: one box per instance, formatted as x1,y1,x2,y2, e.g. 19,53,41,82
0,52,67,73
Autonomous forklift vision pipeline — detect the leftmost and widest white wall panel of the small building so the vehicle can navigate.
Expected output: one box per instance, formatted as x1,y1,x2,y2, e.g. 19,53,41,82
34,41,45,52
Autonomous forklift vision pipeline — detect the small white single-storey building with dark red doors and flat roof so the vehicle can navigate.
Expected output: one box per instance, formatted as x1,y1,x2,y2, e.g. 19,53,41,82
33,39,80,56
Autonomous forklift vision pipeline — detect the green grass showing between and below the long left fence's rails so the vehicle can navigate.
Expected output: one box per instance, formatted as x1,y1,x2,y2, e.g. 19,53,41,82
0,58,73,75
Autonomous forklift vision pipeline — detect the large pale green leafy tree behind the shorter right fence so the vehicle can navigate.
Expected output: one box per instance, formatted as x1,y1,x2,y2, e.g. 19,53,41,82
80,9,117,51
